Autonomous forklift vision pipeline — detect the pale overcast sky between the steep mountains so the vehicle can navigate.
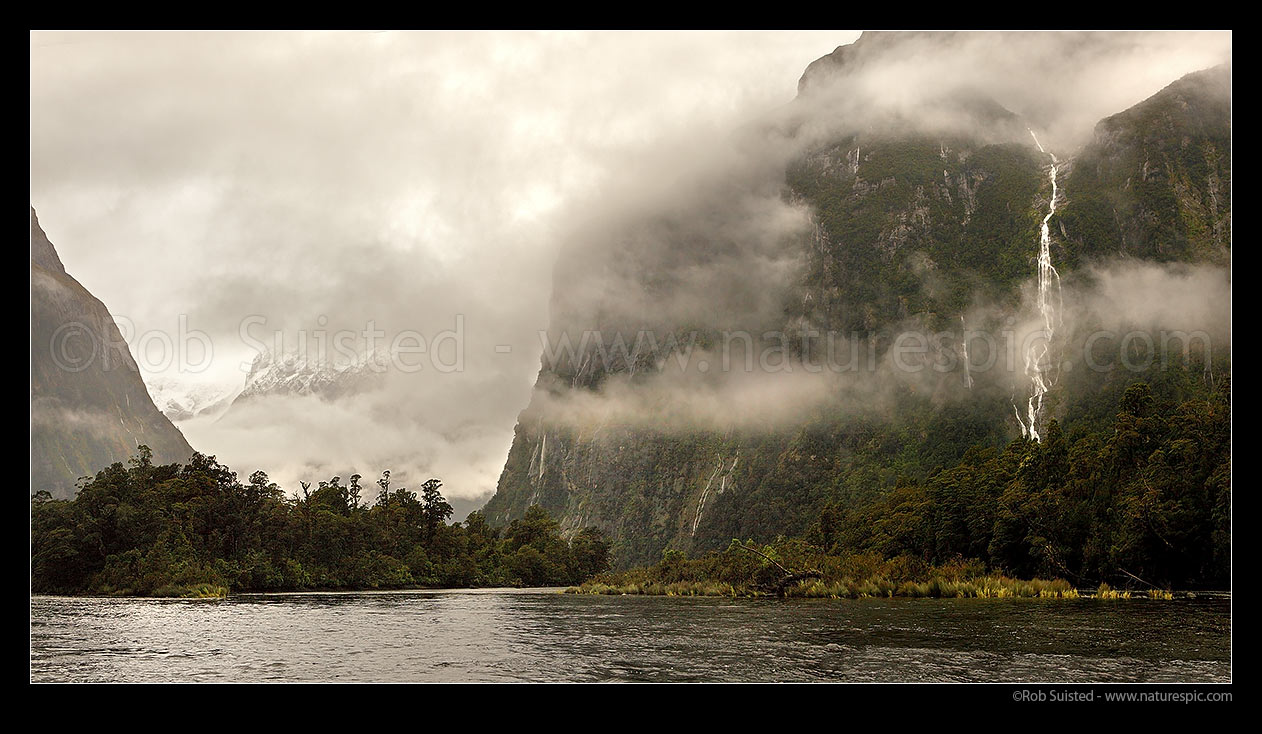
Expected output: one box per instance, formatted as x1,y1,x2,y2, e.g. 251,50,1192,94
30,32,1230,508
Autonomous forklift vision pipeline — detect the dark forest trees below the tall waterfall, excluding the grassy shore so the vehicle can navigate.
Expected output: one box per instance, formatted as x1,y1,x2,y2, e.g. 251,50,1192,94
808,382,1232,588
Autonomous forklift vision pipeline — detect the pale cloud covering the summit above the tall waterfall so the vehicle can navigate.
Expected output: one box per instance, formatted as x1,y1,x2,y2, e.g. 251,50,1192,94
803,32,1232,153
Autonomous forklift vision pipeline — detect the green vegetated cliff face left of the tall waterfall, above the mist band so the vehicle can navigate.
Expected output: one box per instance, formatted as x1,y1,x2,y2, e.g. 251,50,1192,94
786,137,1050,333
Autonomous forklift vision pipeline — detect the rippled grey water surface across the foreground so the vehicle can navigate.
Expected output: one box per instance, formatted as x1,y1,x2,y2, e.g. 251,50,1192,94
30,589,1230,682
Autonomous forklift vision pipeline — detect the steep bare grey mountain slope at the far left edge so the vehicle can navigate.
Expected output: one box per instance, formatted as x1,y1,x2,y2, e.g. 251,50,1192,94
30,209,193,497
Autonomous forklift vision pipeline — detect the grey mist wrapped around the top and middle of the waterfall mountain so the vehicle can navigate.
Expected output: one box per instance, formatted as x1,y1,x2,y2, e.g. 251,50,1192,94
509,33,1230,443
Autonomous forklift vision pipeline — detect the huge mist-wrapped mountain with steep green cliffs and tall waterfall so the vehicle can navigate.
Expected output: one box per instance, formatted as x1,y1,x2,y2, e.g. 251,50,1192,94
485,34,1230,566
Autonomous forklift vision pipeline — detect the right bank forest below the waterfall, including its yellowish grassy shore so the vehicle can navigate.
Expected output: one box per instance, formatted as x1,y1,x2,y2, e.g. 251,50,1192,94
575,381,1232,598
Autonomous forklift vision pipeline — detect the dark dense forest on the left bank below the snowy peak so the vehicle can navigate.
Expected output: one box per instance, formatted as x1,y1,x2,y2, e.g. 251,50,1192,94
30,459,608,597
